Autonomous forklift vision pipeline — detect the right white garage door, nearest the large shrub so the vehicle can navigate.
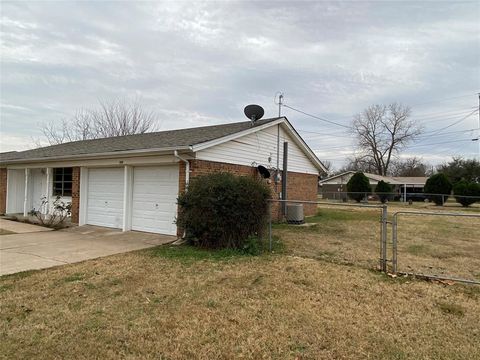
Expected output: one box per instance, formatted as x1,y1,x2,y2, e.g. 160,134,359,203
132,165,178,235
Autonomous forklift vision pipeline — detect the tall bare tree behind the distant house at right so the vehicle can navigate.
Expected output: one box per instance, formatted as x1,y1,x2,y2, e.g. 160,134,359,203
352,103,422,175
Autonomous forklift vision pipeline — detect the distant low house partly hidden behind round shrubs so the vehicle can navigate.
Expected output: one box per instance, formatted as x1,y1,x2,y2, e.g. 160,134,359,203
318,171,428,201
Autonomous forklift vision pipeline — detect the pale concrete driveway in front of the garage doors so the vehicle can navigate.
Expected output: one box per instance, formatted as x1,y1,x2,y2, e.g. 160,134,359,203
0,219,176,275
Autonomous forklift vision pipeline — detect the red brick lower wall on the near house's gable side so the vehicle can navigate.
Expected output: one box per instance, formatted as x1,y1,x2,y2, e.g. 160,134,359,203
179,160,318,220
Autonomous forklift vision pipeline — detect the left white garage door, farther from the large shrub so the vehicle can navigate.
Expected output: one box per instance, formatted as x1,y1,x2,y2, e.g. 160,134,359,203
87,168,124,228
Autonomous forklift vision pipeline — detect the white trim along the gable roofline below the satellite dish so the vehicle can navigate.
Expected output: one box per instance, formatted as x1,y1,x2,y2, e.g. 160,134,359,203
192,117,327,172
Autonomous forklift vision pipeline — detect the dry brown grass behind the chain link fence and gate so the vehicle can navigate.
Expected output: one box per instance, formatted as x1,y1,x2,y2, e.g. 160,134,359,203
275,204,480,281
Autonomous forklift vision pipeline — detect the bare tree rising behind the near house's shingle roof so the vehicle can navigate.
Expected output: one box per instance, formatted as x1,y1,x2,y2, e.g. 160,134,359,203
41,99,156,145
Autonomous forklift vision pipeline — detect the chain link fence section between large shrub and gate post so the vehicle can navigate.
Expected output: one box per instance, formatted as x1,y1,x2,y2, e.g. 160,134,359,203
269,200,387,270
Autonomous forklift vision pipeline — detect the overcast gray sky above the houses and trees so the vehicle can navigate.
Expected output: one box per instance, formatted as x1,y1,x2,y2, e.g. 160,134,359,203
0,1,480,167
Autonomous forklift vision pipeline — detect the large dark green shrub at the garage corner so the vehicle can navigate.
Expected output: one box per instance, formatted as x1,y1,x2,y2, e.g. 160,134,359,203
177,173,270,252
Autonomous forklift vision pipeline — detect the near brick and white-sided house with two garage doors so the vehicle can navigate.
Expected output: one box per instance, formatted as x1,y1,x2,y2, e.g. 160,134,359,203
0,117,325,235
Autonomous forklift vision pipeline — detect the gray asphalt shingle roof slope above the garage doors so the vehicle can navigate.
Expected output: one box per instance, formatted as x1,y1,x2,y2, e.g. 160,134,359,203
0,118,279,163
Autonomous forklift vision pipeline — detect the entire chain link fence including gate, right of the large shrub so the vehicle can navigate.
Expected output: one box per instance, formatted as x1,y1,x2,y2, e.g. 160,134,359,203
268,200,480,284
